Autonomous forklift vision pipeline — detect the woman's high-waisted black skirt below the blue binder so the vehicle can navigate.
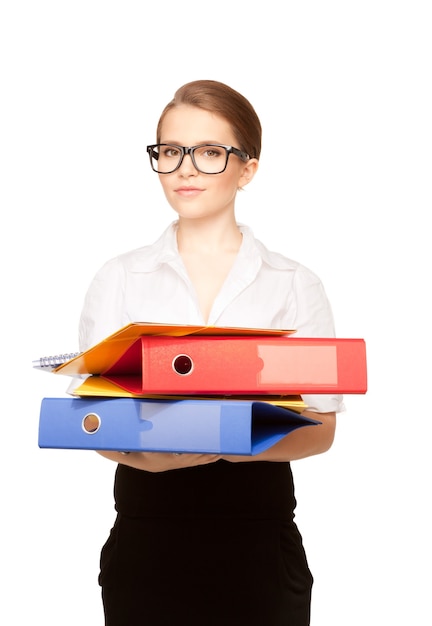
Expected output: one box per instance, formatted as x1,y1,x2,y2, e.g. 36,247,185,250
99,461,312,626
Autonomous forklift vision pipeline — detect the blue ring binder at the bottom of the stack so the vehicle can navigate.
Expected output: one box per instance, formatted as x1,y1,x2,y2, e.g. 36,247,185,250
39,398,320,455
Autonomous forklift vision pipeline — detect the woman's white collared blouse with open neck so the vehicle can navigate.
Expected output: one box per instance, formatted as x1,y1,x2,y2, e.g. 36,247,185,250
75,222,344,412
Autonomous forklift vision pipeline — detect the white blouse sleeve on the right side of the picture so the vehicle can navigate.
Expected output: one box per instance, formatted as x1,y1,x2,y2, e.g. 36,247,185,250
294,266,345,413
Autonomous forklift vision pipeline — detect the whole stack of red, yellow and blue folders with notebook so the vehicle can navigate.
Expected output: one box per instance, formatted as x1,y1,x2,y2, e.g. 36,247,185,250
33,323,367,455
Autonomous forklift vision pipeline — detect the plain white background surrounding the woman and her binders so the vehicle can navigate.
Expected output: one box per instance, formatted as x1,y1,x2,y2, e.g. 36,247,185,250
0,0,432,626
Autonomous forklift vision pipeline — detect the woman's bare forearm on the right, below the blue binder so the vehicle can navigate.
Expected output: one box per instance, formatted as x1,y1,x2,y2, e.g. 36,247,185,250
222,410,336,462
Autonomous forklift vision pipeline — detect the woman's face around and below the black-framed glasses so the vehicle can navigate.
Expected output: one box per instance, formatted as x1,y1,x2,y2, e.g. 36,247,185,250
155,105,258,219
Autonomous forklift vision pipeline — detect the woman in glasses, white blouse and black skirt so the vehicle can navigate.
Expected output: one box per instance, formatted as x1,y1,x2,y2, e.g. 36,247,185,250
80,80,343,626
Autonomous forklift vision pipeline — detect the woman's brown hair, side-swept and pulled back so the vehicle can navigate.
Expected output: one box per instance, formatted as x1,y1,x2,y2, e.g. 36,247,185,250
156,80,261,159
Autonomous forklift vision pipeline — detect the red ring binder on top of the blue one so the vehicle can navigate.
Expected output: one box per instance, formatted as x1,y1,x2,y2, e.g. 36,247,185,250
58,335,367,396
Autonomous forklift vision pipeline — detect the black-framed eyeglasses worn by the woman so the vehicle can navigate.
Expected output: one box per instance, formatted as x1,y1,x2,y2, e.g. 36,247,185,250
147,143,250,174
